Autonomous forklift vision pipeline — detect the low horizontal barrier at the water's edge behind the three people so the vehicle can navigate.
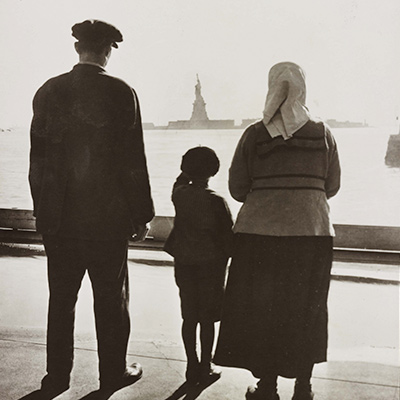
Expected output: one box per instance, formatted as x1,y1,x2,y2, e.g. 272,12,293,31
0,208,400,265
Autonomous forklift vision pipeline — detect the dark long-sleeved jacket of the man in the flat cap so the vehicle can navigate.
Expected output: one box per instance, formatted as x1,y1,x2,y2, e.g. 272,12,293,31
29,64,154,240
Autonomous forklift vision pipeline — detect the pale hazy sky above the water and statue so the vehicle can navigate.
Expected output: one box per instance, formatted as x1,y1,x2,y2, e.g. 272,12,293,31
0,0,400,128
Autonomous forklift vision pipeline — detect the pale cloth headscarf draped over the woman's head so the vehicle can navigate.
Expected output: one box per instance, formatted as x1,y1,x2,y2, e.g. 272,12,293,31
263,62,310,140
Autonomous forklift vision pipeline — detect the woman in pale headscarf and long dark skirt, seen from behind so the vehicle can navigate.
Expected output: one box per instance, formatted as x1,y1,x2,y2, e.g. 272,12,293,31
214,62,340,400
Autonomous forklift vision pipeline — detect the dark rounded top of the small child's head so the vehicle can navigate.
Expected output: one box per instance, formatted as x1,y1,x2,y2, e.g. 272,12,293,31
181,146,219,179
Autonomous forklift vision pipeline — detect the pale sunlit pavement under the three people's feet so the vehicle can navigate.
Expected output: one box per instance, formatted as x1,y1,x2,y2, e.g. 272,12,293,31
0,250,400,400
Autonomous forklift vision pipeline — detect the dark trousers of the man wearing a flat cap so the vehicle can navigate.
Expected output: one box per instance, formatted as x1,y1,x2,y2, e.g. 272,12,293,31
43,236,130,383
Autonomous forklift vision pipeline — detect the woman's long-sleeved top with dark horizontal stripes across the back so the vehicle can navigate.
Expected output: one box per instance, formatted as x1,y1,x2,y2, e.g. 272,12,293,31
229,120,340,236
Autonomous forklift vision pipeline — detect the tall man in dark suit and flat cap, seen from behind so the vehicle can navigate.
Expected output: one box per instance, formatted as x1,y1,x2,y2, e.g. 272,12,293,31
29,20,154,398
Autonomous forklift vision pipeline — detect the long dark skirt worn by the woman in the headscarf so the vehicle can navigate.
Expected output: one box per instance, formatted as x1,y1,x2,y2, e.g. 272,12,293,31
214,234,332,378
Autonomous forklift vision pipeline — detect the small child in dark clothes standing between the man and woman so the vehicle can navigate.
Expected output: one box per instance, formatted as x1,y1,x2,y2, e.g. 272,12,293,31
164,147,233,384
